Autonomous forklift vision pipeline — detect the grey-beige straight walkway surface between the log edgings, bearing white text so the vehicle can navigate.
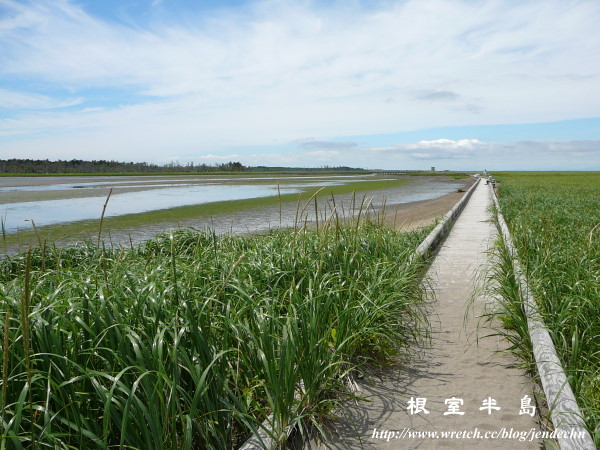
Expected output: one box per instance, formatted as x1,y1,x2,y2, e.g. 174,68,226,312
305,183,541,449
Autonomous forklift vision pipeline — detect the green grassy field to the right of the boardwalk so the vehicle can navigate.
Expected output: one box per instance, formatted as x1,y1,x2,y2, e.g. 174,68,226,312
494,172,600,445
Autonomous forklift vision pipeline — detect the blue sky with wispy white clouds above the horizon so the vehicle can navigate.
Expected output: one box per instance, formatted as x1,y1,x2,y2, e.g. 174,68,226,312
0,0,600,170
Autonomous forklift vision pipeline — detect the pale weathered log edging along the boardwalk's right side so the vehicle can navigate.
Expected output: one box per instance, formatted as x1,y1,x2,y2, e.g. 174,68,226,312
490,187,596,450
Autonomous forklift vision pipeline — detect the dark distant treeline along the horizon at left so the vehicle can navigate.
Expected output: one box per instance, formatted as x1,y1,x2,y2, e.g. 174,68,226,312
0,159,362,174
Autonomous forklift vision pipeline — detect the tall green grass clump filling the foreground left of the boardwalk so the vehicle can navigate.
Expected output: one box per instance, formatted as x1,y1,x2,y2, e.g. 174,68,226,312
0,210,429,449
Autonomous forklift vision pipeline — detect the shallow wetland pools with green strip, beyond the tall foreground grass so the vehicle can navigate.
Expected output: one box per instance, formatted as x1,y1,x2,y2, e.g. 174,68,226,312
0,175,471,254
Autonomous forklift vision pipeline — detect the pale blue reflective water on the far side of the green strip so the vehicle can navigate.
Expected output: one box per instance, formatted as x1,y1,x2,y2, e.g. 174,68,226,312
0,177,360,233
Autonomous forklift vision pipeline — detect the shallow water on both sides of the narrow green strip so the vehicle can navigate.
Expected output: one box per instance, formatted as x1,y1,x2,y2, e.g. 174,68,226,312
0,175,469,253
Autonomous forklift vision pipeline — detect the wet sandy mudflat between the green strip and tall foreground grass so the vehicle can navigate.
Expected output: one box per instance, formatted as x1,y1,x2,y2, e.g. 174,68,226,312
0,176,473,254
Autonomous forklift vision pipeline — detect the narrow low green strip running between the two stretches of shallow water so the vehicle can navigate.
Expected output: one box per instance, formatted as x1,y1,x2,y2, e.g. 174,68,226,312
2,179,408,248
